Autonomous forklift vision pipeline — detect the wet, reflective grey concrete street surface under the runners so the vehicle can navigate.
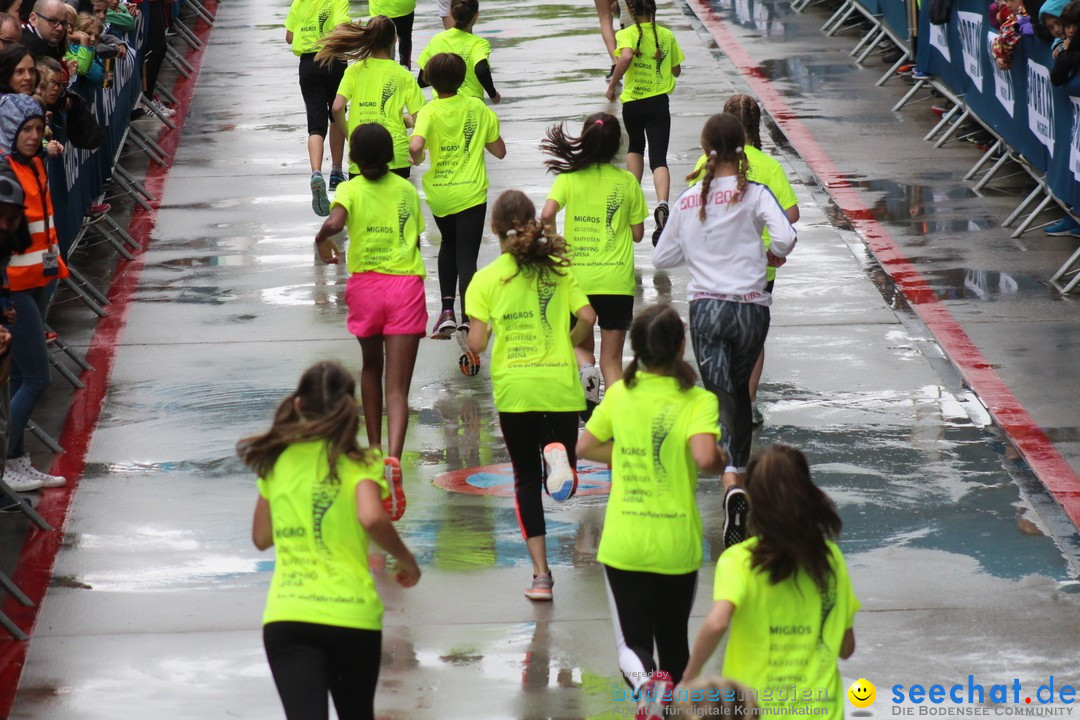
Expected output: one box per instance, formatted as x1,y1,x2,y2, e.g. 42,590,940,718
11,0,1080,720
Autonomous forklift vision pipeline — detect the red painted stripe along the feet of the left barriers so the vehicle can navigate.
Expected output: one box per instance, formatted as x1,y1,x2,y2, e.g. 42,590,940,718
0,0,217,718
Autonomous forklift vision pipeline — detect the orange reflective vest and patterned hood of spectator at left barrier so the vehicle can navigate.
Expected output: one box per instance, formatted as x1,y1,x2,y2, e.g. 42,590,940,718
0,93,68,291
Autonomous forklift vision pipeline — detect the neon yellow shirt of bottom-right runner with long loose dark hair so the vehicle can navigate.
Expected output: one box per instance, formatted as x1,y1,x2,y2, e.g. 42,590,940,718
713,538,860,720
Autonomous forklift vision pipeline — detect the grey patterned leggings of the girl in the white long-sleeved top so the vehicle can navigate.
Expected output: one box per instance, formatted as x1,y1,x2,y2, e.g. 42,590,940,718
690,299,769,468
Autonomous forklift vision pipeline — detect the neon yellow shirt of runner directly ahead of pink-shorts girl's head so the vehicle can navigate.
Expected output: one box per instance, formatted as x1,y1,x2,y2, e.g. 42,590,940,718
338,57,423,175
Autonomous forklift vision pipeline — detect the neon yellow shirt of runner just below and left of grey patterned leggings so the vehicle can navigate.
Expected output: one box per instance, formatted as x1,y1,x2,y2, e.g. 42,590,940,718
585,370,720,575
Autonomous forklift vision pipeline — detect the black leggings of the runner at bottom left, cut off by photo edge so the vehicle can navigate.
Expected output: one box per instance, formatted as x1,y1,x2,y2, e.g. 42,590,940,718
262,623,382,720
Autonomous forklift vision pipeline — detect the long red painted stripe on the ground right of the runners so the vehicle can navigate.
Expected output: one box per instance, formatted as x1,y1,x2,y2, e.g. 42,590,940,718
687,0,1080,528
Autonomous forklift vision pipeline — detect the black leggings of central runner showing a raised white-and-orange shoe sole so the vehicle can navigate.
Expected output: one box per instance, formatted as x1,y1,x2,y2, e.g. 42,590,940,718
499,410,578,540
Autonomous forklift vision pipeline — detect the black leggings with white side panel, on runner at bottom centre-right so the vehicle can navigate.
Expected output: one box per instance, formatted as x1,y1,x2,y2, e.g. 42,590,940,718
604,566,698,690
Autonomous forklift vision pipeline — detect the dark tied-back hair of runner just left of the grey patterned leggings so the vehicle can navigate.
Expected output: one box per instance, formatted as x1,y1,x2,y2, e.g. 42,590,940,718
622,304,698,390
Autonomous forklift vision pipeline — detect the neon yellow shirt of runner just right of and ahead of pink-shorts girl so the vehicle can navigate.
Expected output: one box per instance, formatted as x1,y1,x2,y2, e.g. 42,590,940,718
413,95,499,217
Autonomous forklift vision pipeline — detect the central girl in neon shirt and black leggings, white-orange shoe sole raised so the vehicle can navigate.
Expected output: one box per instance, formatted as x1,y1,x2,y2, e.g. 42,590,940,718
469,190,596,600
